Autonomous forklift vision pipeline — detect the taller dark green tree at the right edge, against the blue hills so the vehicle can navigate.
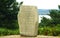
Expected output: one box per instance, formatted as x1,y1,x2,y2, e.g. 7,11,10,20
50,10,60,25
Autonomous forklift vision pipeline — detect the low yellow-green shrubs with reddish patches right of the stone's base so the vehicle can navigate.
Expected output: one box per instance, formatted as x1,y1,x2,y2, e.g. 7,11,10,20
38,27,60,36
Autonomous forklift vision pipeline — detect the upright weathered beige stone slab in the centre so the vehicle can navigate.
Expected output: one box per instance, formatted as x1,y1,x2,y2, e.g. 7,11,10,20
18,6,38,36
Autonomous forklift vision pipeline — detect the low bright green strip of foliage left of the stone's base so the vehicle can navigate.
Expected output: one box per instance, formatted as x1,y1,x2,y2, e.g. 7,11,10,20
0,28,19,36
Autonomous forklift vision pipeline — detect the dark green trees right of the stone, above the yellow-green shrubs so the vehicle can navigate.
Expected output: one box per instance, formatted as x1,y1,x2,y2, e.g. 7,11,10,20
40,6,60,26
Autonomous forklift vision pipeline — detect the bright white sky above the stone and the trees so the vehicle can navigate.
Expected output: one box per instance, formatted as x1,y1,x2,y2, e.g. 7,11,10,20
17,0,60,9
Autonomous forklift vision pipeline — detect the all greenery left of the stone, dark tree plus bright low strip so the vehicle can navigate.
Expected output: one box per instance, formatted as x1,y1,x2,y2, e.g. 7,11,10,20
0,0,19,36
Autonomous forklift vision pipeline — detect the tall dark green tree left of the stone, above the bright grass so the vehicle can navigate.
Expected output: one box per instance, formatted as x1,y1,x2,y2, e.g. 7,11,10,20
0,0,18,28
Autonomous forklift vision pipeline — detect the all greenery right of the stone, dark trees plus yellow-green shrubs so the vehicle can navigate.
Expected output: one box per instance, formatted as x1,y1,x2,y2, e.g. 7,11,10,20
38,7,60,36
